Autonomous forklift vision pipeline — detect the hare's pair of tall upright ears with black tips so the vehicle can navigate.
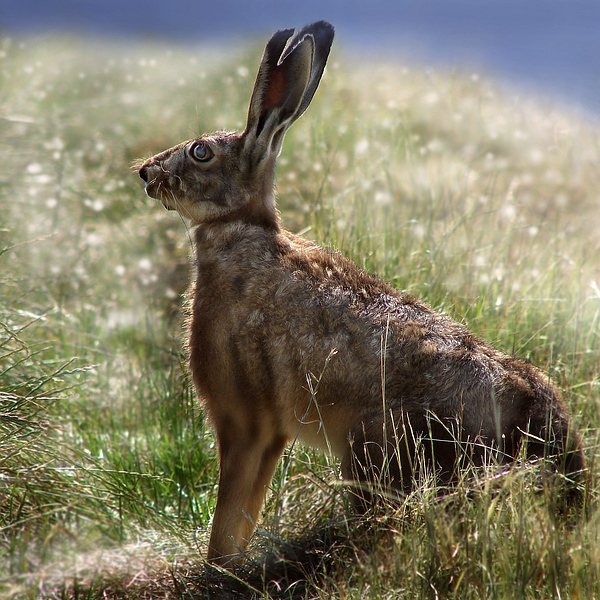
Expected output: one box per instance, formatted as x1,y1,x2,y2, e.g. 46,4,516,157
244,21,334,162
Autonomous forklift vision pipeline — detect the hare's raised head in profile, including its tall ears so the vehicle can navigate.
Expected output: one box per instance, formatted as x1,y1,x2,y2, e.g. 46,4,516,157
139,21,333,225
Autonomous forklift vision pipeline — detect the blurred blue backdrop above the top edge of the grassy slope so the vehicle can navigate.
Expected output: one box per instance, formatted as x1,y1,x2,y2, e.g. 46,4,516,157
0,0,600,119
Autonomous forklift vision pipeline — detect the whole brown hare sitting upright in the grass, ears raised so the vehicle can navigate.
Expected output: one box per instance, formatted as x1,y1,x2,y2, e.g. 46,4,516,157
139,21,584,567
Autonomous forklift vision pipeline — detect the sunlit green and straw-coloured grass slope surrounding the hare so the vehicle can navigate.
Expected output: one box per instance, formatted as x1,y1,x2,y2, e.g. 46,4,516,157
0,37,600,599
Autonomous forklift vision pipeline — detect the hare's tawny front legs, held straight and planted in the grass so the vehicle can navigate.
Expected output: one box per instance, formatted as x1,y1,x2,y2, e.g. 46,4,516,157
207,422,287,566
